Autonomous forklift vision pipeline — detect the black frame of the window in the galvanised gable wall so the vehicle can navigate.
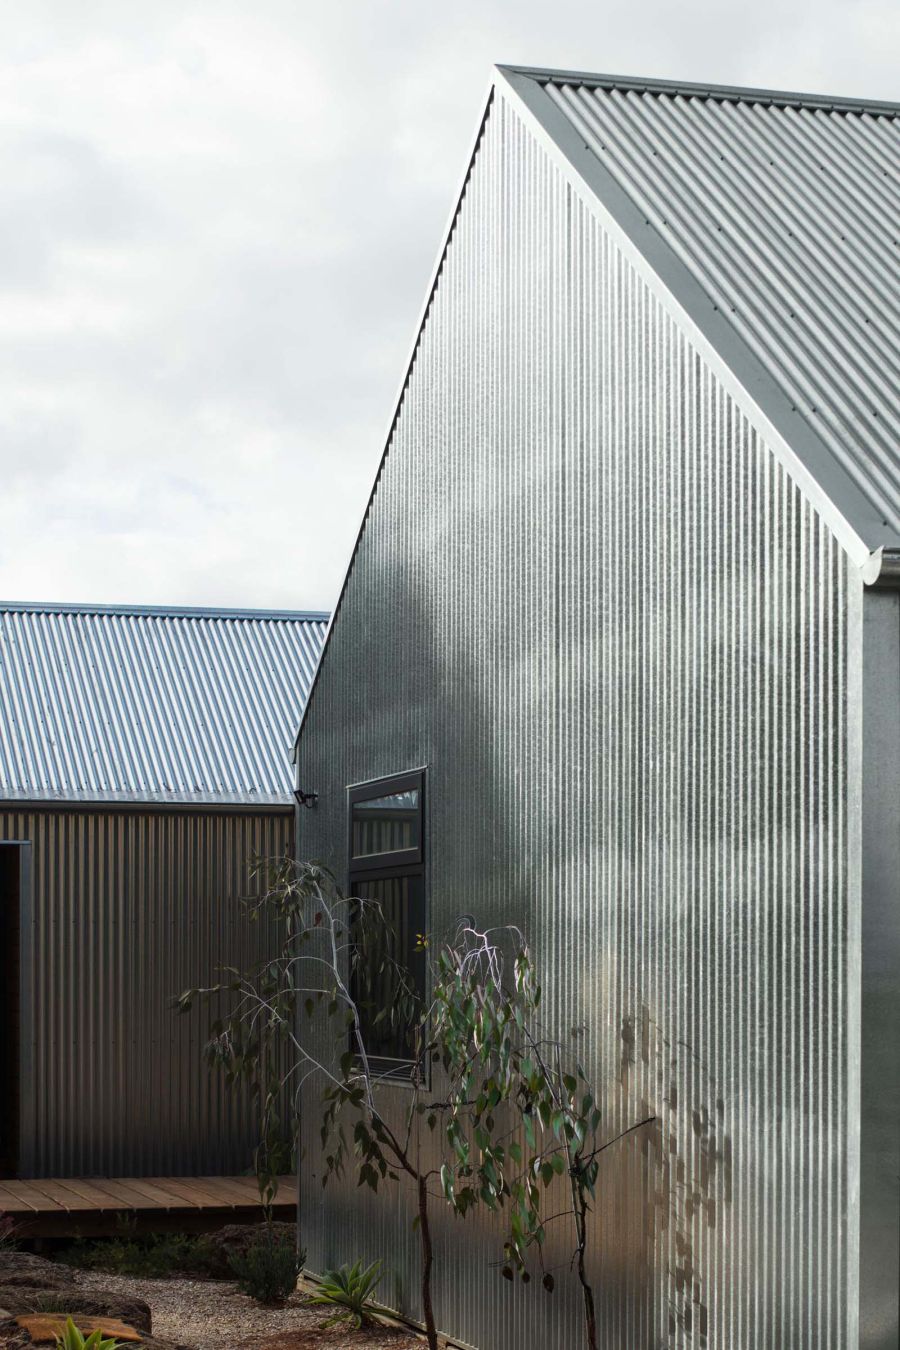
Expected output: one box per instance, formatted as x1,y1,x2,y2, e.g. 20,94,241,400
347,768,428,1084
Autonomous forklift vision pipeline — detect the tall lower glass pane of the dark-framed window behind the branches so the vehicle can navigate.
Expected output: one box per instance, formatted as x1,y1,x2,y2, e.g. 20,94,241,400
354,876,425,1067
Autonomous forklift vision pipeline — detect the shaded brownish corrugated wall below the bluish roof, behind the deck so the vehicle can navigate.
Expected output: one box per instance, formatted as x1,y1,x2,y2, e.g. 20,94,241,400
0,807,291,1176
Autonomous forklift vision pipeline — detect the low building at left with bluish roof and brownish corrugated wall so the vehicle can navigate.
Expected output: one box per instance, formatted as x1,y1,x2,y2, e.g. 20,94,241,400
0,605,327,1177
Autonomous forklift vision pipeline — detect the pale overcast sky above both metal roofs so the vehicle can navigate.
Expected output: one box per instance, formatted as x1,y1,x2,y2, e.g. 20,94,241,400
0,0,900,609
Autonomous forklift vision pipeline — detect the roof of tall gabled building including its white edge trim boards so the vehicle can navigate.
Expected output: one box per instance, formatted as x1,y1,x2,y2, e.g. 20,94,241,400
298,66,900,738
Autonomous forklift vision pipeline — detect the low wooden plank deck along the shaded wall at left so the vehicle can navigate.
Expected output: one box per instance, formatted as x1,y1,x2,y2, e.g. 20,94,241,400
0,1177,297,1238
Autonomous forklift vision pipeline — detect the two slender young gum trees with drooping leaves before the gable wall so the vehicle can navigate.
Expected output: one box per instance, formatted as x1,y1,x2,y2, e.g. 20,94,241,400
183,859,656,1350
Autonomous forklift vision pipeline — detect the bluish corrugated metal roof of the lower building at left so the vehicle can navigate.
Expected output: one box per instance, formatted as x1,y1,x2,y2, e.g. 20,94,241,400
0,602,328,806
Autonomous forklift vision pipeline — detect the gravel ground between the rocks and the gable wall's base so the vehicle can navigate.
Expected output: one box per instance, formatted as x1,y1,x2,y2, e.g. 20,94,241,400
74,1270,422,1350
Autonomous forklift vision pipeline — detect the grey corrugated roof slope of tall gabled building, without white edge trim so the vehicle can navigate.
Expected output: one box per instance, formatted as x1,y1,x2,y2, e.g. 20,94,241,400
507,72,900,547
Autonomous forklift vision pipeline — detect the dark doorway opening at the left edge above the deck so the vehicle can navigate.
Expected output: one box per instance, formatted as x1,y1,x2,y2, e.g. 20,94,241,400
0,844,24,1177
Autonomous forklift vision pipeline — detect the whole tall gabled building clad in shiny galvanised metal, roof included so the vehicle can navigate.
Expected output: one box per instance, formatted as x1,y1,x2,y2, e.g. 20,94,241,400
298,69,900,1350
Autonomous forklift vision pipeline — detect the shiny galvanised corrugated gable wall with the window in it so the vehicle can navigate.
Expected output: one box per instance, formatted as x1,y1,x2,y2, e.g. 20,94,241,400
300,100,861,1350
